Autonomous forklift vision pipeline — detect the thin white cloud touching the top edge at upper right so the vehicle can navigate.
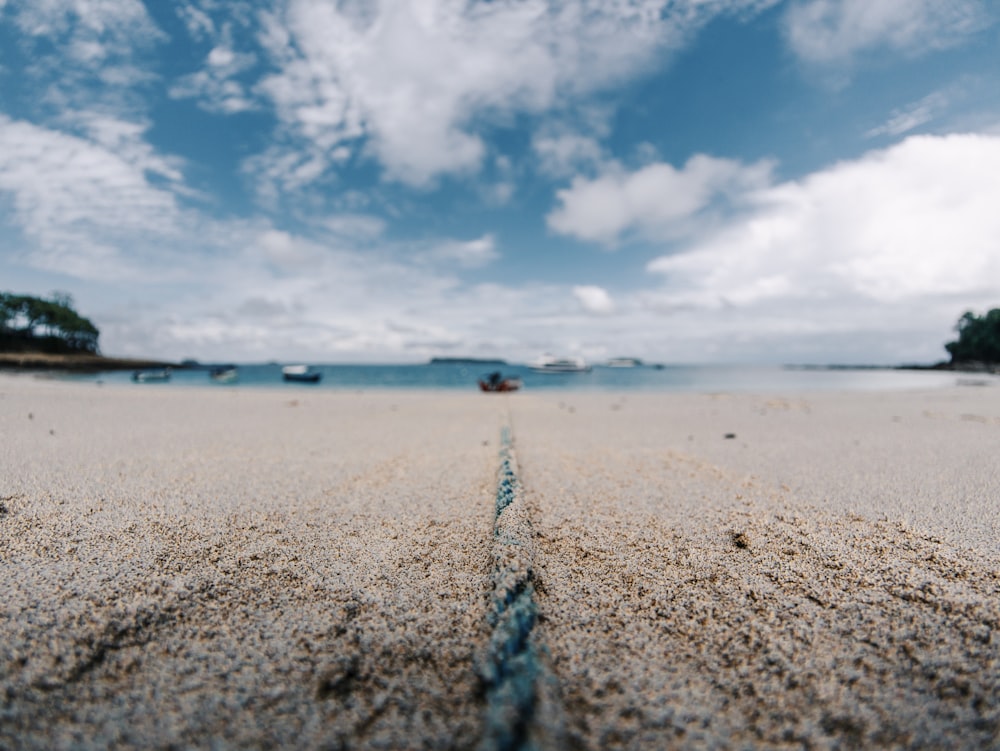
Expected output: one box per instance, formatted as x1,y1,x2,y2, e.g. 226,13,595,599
786,0,990,63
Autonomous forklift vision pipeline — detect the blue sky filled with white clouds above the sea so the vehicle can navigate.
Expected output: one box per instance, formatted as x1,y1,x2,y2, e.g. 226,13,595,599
0,0,1000,364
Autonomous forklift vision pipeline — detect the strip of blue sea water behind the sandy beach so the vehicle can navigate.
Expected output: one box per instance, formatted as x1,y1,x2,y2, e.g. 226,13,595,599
66,363,976,393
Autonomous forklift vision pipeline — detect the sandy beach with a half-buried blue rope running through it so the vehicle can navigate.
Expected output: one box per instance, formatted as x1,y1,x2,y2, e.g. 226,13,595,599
0,376,1000,749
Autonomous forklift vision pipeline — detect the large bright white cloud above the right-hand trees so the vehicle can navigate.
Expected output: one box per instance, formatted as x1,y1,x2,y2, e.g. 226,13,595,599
647,135,1000,350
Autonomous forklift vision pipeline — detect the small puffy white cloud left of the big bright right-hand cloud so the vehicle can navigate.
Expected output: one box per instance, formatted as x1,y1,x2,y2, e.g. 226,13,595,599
548,154,771,244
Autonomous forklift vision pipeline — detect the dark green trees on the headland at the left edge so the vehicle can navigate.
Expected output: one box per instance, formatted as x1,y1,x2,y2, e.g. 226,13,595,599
0,292,100,355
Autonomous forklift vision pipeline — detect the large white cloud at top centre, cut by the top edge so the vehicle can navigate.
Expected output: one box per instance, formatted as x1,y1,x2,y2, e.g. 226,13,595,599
252,0,774,185
